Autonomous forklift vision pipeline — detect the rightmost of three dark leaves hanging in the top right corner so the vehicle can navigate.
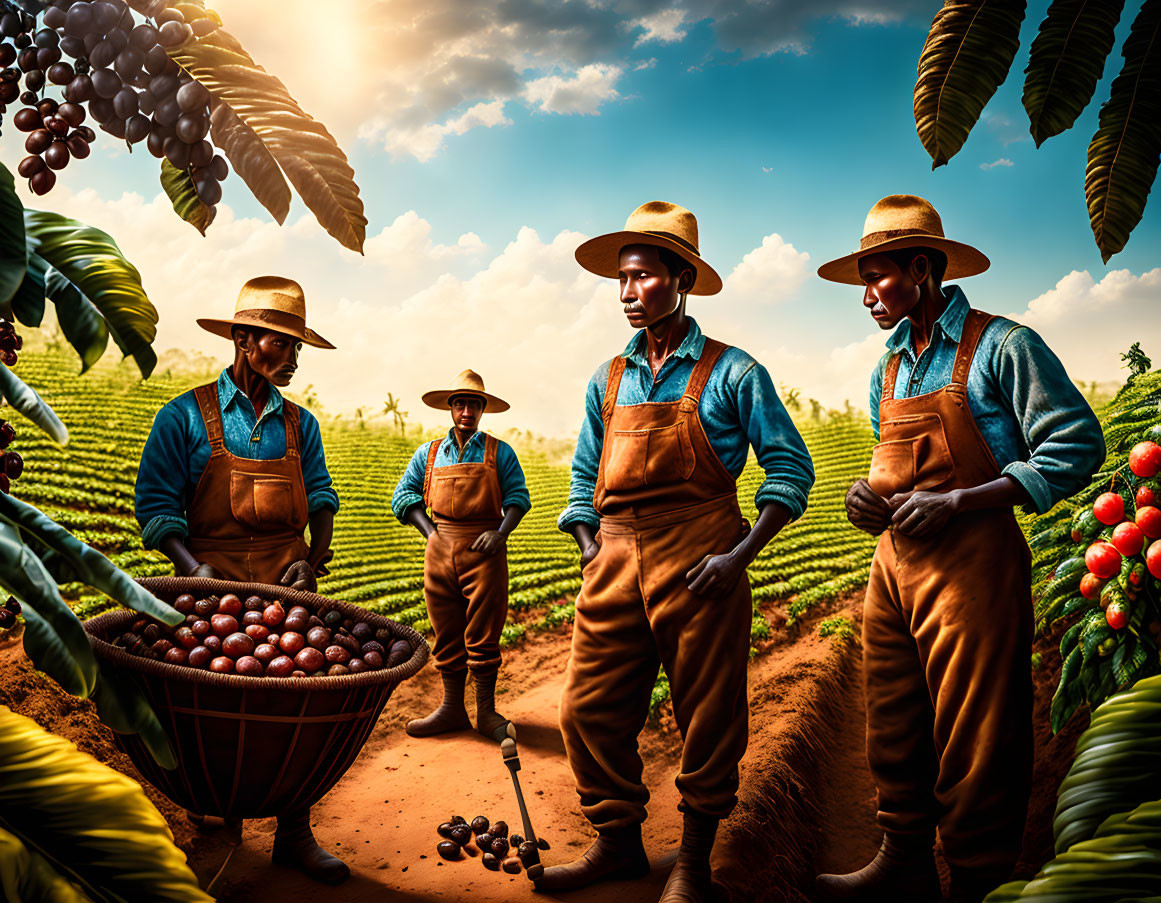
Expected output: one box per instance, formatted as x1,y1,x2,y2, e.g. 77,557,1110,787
1084,0,1161,263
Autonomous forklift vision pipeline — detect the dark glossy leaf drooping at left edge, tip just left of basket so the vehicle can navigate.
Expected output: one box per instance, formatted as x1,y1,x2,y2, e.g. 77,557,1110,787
0,523,96,696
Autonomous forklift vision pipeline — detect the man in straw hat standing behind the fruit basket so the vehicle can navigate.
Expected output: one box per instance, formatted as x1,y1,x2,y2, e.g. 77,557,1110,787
136,276,347,883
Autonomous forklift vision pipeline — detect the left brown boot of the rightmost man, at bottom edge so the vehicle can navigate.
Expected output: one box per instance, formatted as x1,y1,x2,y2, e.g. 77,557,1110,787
814,835,943,903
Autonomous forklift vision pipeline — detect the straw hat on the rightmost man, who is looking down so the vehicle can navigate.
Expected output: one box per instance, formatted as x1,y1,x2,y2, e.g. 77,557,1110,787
819,194,990,286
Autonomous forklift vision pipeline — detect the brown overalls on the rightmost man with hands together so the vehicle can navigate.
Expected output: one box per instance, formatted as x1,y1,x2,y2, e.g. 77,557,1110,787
863,310,1032,880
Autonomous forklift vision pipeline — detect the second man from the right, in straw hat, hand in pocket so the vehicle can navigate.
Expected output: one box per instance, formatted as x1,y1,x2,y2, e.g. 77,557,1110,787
536,201,814,903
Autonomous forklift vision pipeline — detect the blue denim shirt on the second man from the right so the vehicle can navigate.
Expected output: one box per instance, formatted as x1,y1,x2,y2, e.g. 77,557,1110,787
557,317,814,532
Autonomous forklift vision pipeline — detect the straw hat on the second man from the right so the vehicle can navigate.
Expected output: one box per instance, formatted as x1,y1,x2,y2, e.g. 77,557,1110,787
576,201,722,295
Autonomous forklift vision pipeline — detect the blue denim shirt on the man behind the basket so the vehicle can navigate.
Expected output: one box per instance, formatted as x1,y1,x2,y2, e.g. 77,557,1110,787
136,368,339,549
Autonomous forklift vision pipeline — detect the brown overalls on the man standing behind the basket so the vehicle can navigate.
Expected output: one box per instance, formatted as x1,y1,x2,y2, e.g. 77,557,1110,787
186,383,310,584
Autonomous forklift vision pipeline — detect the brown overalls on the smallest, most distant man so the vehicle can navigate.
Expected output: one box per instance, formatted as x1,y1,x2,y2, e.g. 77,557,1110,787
424,435,507,674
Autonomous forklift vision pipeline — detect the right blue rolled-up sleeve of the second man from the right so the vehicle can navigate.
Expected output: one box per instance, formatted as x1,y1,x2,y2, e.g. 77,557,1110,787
735,362,814,520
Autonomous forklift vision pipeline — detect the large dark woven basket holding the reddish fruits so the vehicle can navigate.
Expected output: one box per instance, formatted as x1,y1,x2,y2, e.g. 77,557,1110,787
85,577,428,818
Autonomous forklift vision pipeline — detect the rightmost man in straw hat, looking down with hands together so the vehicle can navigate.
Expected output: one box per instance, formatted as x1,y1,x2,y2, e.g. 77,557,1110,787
817,195,1105,903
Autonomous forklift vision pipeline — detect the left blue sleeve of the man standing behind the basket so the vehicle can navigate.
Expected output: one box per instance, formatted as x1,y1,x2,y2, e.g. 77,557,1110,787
134,402,190,549
